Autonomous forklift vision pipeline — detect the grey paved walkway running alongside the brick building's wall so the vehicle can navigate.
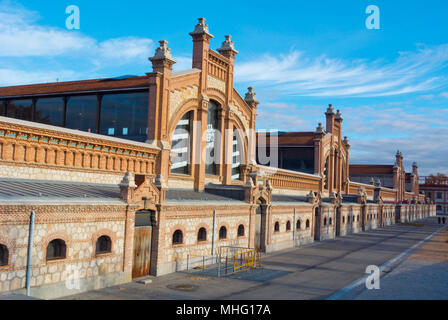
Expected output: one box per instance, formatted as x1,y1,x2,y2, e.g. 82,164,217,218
64,217,448,300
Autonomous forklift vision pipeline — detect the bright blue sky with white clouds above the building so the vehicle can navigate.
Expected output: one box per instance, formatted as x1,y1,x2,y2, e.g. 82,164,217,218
0,0,448,174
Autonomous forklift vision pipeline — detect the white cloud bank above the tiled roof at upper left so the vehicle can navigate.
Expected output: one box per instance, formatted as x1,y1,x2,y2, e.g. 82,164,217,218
0,1,154,85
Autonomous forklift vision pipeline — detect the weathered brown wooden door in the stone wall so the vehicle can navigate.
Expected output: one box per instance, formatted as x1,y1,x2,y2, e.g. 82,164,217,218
132,226,152,278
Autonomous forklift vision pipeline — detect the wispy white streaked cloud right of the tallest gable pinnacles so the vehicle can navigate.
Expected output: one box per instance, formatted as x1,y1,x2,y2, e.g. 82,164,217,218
235,44,448,97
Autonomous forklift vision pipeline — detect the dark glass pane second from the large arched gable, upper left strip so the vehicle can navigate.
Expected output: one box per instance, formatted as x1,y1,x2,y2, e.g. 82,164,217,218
65,95,98,132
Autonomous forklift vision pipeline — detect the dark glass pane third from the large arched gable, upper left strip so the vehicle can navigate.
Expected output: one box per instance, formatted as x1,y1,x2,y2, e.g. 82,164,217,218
36,98,64,126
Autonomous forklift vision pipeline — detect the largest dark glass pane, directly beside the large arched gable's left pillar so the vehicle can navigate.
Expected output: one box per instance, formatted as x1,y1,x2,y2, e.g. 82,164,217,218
100,91,148,141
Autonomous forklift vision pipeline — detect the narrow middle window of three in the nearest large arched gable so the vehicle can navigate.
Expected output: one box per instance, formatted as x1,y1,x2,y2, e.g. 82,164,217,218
205,101,219,175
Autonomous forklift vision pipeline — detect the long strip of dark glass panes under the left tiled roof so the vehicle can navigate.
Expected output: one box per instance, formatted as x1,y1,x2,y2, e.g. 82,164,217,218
0,90,149,142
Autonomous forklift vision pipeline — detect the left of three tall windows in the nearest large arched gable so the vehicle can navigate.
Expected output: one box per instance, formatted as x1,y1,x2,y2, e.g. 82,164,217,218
171,111,193,174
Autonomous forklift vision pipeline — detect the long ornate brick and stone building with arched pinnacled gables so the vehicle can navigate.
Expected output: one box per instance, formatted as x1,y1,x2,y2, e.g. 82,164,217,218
0,18,434,298
